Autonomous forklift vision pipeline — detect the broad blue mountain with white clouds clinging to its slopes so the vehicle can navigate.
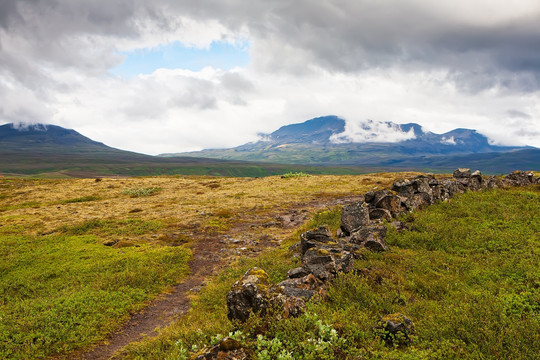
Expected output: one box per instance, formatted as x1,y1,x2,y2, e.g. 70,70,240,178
167,116,540,173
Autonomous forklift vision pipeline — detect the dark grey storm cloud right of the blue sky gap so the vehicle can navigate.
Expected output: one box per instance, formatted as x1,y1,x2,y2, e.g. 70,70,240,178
166,0,540,92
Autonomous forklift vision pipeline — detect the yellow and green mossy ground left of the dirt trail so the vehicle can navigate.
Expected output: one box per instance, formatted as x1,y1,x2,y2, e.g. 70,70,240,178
0,173,407,359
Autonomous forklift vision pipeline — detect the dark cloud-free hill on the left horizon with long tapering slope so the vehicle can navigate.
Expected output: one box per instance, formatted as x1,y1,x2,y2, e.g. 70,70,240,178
0,124,366,177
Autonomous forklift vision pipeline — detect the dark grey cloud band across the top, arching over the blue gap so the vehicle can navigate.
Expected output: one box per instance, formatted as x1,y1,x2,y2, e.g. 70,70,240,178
0,0,540,92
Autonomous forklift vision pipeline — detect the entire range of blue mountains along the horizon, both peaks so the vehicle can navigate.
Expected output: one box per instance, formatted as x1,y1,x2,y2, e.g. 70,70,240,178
0,116,540,177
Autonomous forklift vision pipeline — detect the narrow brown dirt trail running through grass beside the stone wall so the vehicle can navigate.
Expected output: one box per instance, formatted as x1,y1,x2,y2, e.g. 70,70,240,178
74,196,360,360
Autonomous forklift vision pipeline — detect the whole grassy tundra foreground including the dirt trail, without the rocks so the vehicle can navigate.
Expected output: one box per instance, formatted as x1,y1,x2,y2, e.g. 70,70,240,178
0,173,540,359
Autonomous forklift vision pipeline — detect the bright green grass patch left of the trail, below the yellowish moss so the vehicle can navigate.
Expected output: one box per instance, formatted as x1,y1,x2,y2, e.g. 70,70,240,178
0,235,190,359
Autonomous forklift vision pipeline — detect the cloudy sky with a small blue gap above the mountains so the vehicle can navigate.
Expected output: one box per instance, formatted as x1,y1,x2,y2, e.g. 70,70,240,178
0,0,540,154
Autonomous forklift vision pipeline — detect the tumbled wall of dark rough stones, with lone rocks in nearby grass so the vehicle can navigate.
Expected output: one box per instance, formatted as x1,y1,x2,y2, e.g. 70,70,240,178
194,169,540,359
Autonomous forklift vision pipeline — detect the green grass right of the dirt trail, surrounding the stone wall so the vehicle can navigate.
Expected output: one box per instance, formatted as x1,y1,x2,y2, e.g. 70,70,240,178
122,186,540,359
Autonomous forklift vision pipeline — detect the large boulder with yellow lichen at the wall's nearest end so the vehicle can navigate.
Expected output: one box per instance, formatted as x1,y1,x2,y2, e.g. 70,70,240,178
227,267,271,322
